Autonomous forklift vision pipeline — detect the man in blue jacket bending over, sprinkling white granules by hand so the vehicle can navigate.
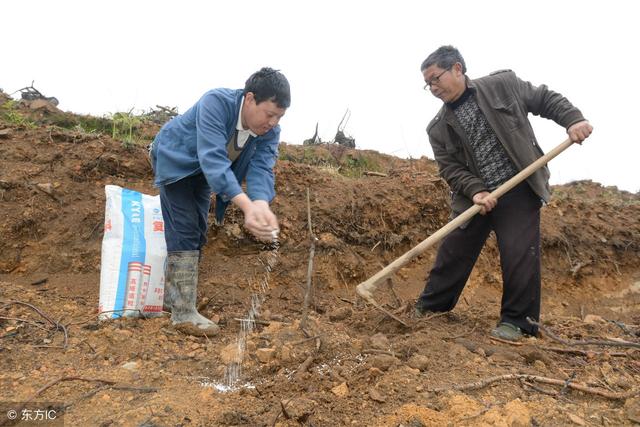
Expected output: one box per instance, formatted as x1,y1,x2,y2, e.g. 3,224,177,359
150,68,291,336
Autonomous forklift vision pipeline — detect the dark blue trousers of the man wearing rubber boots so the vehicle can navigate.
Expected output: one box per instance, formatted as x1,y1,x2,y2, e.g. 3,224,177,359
160,174,211,252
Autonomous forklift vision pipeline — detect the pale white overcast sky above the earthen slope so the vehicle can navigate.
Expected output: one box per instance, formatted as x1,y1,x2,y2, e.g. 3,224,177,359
0,0,640,192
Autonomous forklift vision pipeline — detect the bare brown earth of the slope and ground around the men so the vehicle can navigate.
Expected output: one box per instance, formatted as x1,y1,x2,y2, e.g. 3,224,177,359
0,93,640,426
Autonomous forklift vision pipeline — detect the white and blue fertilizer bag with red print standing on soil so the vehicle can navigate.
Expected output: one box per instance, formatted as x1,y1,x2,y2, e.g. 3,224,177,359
98,185,167,320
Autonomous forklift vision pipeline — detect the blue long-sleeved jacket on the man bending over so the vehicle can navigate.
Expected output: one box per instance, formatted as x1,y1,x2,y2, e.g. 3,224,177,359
151,89,280,222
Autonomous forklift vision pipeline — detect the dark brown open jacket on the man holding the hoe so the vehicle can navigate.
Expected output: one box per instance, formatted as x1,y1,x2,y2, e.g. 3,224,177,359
427,70,584,217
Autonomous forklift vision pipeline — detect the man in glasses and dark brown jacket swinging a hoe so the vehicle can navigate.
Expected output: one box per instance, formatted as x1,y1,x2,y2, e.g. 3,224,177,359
416,46,593,340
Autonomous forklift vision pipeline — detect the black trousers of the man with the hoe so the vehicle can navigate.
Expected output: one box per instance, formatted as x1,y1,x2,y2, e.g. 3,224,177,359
416,183,541,335
